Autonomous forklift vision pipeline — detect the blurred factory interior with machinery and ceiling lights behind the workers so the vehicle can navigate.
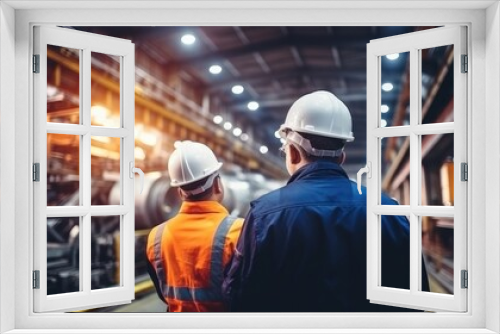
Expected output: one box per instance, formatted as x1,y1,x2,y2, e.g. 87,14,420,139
47,26,453,312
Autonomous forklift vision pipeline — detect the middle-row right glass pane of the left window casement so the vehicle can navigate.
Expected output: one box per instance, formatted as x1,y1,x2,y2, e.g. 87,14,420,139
90,136,121,205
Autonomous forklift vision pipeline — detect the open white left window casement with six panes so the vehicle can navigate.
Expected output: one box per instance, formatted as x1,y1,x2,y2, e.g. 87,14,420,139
33,26,135,312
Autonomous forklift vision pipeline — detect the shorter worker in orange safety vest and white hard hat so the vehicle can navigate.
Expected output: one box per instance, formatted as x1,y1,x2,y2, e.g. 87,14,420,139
146,141,243,312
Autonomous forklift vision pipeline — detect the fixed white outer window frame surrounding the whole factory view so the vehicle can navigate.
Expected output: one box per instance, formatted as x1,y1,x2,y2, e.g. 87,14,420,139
0,1,500,333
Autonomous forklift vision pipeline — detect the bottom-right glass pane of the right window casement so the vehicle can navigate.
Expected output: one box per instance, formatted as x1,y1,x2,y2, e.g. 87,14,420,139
421,216,454,294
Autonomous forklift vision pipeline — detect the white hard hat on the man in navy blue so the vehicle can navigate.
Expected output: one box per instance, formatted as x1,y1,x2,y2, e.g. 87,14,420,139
279,90,354,142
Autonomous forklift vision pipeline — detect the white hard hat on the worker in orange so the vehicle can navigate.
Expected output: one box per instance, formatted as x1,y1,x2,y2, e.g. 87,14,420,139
168,140,222,187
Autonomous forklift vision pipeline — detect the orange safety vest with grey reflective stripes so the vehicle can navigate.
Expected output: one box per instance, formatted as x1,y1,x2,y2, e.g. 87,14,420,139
147,201,243,312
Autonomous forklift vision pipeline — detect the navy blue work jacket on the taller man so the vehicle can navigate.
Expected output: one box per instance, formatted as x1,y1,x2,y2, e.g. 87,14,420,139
223,161,428,312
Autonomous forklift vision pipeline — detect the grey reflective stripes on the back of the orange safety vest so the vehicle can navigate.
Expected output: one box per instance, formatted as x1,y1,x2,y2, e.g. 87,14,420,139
154,216,236,302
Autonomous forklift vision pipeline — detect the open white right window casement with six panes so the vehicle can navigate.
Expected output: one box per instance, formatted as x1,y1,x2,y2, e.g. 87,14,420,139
367,25,472,312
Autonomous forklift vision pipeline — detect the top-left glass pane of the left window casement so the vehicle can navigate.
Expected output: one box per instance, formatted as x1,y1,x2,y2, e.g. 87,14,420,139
47,45,80,124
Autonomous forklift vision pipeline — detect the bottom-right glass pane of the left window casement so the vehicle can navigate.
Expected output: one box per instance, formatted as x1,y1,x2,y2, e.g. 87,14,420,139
91,216,121,290
